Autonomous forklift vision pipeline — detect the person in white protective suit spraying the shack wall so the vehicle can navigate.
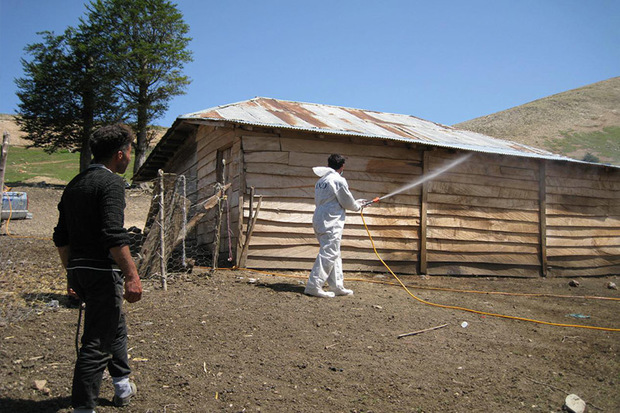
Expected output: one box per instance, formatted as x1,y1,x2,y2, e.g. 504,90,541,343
304,154,366,297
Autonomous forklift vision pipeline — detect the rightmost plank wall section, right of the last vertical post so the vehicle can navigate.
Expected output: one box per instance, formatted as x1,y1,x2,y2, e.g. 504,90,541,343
546,163,620,276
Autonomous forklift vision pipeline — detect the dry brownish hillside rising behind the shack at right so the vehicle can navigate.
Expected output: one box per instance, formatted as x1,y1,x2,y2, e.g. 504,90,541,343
454,77,620,165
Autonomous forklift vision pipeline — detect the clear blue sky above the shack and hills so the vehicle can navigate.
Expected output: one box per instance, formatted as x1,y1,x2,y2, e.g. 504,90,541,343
0,0,620,126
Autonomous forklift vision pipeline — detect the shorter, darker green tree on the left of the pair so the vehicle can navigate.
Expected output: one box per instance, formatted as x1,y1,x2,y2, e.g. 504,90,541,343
15,25,122,170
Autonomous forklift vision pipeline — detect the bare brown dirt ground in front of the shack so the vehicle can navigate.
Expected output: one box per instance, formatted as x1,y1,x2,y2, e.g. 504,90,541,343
0,186,620,413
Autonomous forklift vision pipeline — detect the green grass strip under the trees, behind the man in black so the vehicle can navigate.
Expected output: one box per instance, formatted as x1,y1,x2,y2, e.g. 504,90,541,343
4,146,134,184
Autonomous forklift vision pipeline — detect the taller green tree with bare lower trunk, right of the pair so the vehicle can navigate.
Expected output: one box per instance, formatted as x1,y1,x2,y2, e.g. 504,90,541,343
88,0,192,172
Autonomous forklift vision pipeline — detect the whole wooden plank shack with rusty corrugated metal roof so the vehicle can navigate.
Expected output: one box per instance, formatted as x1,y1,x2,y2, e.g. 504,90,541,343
135,98,620,277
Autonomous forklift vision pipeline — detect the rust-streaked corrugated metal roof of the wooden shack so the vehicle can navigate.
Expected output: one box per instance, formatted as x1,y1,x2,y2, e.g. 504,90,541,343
179,97,596,163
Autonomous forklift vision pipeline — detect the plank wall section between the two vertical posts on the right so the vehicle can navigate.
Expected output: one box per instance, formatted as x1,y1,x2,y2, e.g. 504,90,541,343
426,150,540,277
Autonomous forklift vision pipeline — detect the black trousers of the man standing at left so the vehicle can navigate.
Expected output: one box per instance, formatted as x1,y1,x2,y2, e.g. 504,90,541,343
67,262,131,409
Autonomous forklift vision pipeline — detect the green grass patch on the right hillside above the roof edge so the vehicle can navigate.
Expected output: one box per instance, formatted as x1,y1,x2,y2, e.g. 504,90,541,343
548,126,620,165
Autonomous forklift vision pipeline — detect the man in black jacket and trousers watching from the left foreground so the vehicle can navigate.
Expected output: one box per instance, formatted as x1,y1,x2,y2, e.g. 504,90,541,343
54,125,142,413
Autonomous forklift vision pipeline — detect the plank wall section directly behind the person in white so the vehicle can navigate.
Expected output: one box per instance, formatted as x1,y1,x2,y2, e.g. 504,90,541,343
242,134,422,273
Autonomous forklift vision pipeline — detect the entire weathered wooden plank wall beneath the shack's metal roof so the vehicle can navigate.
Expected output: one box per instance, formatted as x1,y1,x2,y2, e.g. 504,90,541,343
190,127,620,277
